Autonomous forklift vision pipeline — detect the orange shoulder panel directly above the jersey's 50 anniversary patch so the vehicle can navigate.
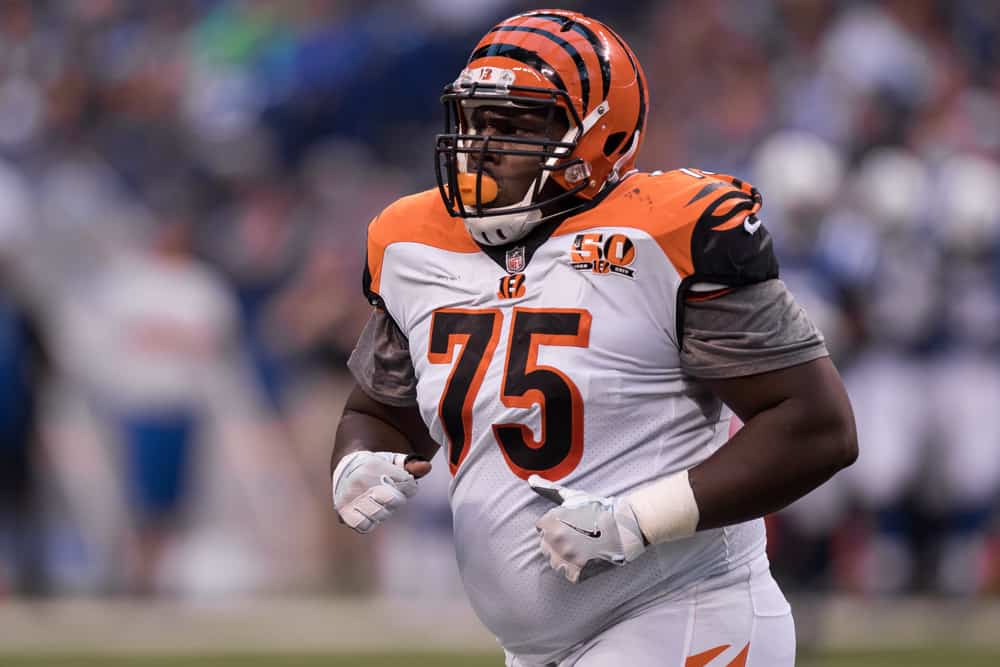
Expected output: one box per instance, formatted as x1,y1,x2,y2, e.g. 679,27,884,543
556,169,760,278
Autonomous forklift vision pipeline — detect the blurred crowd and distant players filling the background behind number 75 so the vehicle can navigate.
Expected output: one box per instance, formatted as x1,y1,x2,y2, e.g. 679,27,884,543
0,0,1000,664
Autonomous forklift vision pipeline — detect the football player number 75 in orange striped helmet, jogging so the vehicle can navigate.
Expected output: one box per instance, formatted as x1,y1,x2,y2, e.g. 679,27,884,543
331,10,857,667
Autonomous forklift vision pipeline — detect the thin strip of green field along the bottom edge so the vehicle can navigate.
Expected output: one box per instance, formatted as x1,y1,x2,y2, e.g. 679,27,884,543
0,647,1000,667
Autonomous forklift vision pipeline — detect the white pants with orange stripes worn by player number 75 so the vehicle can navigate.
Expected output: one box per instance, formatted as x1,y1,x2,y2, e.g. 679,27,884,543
507,557,795,667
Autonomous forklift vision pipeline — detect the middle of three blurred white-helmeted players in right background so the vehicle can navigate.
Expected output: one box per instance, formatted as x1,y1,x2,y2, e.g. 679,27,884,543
845,149,945,593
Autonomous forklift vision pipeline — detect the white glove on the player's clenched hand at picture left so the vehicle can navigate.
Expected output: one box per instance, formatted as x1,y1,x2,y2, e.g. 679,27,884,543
333,452,417,533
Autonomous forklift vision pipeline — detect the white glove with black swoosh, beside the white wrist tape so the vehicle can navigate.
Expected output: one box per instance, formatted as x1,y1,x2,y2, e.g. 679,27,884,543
528,475,646,583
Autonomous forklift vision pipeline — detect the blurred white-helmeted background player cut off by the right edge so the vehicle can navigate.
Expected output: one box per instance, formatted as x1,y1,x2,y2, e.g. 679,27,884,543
933,154,1000,595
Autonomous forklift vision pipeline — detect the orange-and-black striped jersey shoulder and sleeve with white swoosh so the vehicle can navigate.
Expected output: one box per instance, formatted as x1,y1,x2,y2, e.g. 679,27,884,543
556,169,777,286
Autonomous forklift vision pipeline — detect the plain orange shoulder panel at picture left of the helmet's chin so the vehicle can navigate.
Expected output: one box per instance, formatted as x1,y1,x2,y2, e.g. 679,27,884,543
368,189,479,294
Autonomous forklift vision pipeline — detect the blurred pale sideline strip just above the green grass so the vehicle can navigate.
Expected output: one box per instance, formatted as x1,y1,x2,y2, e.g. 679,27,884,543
0,595,1000,655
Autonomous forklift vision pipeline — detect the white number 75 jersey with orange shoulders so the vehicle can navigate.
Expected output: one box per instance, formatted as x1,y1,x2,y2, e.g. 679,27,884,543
366,170,777,662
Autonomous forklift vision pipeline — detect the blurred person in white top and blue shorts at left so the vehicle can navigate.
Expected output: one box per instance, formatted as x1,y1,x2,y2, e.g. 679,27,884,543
84,206,242,594
